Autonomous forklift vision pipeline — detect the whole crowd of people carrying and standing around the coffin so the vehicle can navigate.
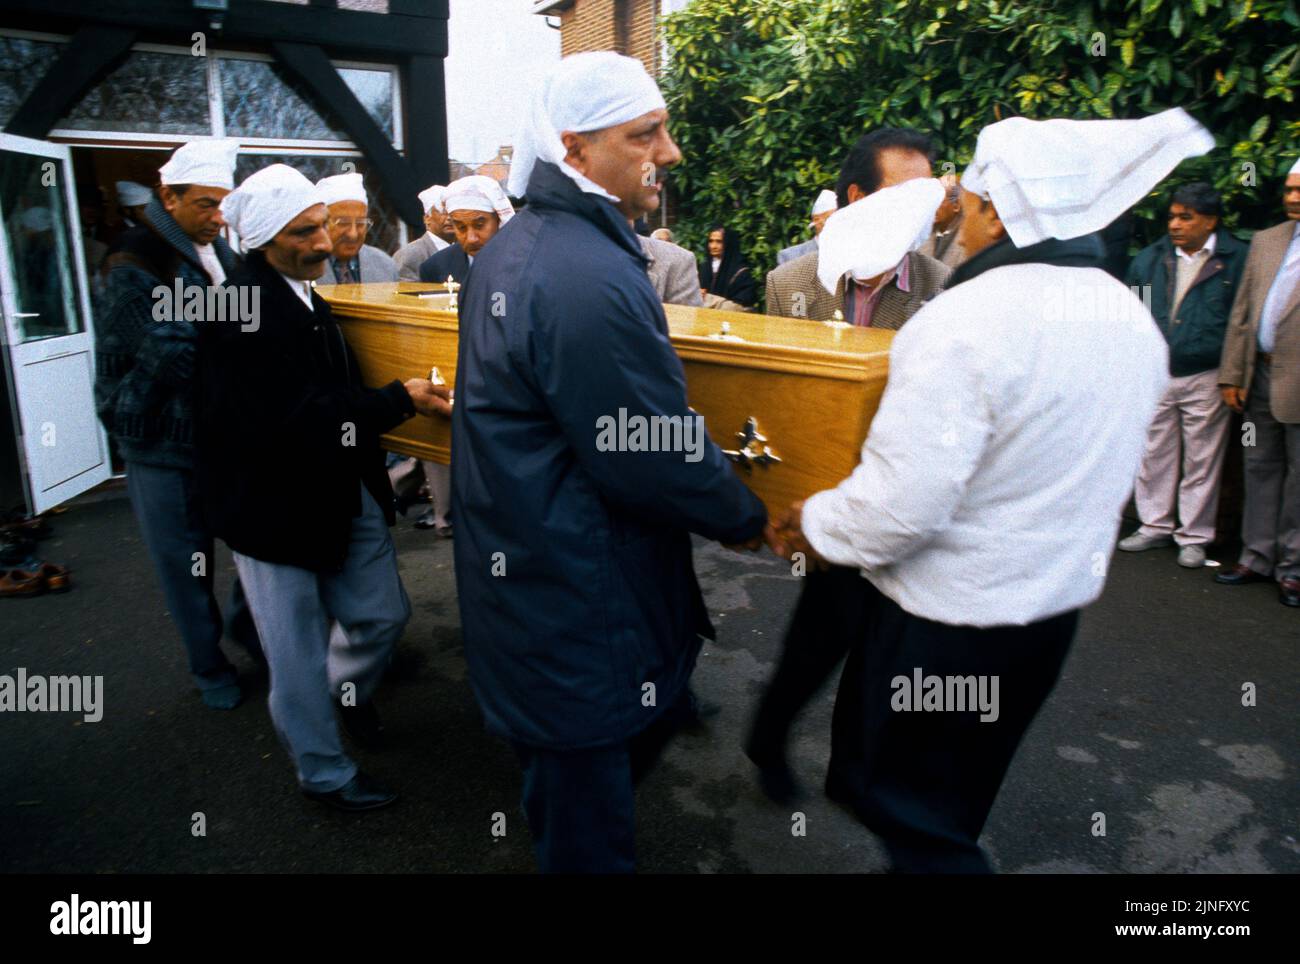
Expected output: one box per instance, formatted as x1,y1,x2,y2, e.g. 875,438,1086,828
96,53,1300,872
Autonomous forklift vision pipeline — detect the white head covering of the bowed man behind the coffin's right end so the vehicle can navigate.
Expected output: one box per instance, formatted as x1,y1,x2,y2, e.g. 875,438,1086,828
816,178,944,292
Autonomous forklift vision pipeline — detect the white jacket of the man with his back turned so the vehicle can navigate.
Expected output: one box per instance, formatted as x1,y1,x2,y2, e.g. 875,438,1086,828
803,265,1169,626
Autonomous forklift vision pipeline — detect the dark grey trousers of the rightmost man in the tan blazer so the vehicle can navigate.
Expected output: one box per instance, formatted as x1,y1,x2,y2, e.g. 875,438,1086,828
1240,362,1300,581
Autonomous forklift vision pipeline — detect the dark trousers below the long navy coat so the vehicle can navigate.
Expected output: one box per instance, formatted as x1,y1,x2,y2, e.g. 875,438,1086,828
514,687,692,873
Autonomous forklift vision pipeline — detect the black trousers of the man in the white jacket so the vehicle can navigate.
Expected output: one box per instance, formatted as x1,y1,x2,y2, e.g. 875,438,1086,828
827,579,1079,873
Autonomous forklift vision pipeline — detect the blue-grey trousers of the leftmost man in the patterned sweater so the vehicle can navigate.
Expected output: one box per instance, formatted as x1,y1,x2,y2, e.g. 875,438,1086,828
126,463,261,690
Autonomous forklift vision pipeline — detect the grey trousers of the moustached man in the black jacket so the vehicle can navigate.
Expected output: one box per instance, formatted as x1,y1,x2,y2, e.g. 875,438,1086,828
235,486,411,793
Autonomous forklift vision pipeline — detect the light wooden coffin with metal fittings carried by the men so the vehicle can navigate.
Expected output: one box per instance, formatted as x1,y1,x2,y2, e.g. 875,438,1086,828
316,282,893,512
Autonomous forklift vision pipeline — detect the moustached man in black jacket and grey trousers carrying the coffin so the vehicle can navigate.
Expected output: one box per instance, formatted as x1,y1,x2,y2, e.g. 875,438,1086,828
199,164,450,811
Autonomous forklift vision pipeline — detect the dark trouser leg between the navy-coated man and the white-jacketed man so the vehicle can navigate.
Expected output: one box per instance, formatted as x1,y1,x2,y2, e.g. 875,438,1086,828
748,565,875,764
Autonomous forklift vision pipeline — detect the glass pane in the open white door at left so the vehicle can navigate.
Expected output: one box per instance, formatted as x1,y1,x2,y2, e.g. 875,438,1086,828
0,151,85,342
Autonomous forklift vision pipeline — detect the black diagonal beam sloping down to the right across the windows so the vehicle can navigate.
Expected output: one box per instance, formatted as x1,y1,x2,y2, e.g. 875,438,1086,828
270,40,423,229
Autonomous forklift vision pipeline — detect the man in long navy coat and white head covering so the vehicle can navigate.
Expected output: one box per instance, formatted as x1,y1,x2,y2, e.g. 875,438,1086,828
447,52,766,872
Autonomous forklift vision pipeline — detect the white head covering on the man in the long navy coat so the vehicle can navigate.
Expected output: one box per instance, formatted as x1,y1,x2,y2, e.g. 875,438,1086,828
510,51,664,201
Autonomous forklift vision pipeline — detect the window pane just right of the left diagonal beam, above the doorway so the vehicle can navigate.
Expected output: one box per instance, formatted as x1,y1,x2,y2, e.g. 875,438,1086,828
56,51,212,134
